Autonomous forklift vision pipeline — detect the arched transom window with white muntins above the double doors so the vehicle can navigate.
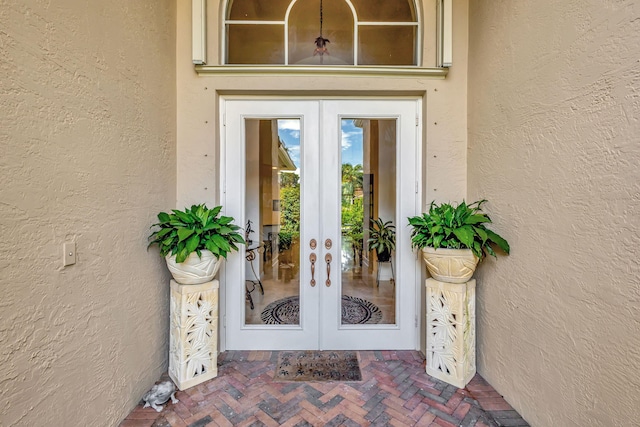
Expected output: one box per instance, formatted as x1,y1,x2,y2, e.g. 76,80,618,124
224,0,419,66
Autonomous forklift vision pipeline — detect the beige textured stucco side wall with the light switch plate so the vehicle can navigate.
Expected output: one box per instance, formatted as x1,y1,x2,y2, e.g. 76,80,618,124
0,0,176,426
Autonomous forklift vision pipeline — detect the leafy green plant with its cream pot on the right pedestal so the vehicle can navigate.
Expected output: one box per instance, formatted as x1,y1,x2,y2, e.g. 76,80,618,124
408,199,509,283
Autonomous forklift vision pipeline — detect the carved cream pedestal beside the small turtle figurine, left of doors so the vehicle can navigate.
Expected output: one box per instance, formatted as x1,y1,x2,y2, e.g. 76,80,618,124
169,280,220,390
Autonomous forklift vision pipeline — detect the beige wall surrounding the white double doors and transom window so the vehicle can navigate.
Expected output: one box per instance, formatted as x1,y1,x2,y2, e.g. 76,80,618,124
176,0,468,348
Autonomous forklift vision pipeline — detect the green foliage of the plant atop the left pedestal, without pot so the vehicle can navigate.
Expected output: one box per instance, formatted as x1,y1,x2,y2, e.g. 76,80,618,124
149,204,245,263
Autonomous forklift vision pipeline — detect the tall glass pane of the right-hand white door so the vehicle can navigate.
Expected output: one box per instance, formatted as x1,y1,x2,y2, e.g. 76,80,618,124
340,118,396,325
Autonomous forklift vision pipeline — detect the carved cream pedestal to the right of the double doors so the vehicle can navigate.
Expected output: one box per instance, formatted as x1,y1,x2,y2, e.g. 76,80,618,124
425,279,476,388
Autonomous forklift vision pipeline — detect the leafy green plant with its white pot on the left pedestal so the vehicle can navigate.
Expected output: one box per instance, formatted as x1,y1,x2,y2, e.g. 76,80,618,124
149,204,245,285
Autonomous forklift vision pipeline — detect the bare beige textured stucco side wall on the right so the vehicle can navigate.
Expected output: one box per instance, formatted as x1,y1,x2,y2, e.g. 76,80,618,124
468,0,640,427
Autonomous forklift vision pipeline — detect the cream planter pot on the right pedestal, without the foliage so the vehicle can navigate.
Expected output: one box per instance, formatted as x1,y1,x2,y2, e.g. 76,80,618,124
422,247,480,283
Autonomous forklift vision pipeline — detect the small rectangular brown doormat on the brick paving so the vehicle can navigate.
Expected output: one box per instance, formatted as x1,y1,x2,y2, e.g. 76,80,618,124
274,351,362,381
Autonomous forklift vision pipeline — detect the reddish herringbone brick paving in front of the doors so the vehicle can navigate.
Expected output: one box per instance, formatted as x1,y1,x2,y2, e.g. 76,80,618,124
120,351,528,427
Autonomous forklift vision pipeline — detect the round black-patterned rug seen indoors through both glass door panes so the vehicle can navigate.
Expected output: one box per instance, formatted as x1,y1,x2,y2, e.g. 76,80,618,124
260,295,382,325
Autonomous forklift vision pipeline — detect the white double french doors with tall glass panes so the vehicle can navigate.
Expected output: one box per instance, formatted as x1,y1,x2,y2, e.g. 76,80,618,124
220,98,421,350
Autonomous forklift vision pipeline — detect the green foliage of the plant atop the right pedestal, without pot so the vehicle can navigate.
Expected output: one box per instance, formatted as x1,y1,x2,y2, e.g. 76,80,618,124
408,199,510,259
